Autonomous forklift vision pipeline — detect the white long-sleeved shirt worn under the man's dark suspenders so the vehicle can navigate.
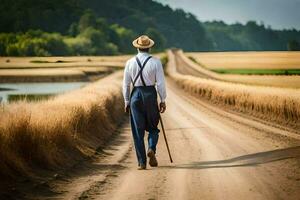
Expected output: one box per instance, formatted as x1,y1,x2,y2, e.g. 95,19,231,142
123,52,167,106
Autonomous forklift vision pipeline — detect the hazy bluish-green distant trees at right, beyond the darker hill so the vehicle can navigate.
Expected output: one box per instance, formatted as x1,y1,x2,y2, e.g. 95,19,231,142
203,21,300,51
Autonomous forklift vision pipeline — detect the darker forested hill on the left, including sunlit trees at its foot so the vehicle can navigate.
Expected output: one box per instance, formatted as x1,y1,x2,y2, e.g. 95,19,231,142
0,0,210,55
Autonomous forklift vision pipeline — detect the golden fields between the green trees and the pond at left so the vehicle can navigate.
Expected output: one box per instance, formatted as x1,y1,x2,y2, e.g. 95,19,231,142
0,55,130,83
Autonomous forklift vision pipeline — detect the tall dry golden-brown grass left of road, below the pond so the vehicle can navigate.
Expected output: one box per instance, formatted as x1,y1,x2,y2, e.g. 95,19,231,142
0,72,123,180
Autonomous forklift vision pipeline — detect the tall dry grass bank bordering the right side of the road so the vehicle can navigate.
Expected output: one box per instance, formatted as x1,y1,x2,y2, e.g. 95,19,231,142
167,51,300,128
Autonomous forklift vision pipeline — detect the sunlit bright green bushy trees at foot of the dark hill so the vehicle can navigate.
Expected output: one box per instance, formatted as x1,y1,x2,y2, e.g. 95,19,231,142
0,10,163,56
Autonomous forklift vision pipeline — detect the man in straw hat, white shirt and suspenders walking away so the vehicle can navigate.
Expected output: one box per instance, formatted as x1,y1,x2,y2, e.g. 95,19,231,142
123,35,166,169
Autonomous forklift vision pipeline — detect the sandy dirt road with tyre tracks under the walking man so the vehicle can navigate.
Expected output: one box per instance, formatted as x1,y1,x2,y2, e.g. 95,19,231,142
35,76,300,200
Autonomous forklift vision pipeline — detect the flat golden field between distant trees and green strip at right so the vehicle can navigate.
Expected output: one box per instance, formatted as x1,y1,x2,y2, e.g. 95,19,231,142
186,51,300,69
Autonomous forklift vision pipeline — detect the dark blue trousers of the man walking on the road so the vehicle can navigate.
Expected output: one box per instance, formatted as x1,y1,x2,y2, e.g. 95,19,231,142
130,86,159,165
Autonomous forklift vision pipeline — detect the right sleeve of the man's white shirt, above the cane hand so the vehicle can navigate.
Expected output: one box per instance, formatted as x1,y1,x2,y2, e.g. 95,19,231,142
155,60,167,102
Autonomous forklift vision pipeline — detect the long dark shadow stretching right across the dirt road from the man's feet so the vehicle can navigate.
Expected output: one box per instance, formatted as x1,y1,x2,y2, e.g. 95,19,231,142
160,146,300,169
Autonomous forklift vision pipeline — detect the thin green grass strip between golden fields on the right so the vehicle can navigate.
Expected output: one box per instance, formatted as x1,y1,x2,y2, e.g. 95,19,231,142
212,69,300,75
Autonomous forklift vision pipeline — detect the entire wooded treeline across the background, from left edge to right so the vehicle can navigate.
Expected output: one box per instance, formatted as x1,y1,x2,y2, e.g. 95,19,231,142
0,0,300,56
